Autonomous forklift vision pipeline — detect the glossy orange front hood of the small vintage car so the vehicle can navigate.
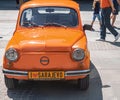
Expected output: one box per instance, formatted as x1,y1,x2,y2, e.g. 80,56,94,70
12,27,84,51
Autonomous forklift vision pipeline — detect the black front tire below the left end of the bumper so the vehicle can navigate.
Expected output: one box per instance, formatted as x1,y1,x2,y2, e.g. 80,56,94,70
4,76,18,89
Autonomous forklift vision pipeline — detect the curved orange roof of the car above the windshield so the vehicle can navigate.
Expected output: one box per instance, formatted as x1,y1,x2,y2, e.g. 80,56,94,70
21,0,79,9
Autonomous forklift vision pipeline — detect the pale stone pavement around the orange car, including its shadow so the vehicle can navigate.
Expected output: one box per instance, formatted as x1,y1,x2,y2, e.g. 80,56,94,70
0,0,120,100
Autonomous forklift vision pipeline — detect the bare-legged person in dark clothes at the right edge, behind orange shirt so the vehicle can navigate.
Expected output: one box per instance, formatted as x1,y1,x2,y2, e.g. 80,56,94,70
111,0,120,26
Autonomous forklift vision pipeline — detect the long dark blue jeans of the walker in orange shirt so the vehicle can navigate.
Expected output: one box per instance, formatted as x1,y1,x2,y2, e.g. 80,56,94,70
100,7,118,39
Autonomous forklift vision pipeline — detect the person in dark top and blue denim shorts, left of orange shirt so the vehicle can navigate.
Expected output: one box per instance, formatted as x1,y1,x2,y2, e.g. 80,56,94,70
91,0,101,30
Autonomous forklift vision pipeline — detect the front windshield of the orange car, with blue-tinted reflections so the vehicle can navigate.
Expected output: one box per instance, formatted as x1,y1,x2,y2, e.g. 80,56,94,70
20,7,78,27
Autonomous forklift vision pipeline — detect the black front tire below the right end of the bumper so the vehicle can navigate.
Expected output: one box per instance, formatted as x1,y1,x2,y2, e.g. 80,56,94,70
78,75,89,90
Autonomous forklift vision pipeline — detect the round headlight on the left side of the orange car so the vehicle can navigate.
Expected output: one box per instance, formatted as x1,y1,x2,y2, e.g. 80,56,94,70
5,48,18,61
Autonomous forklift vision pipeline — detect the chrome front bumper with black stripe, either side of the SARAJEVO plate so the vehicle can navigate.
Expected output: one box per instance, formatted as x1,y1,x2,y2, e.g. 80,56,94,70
3,69,90,76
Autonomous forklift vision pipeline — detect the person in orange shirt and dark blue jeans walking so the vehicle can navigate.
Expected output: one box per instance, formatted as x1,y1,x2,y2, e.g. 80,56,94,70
99,0,120,42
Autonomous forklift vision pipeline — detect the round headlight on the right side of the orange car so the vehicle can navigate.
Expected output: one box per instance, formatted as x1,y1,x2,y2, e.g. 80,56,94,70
72,48,85,61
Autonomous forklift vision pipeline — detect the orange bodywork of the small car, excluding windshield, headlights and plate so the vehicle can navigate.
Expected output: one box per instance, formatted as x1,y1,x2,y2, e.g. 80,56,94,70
3,0,90,80
